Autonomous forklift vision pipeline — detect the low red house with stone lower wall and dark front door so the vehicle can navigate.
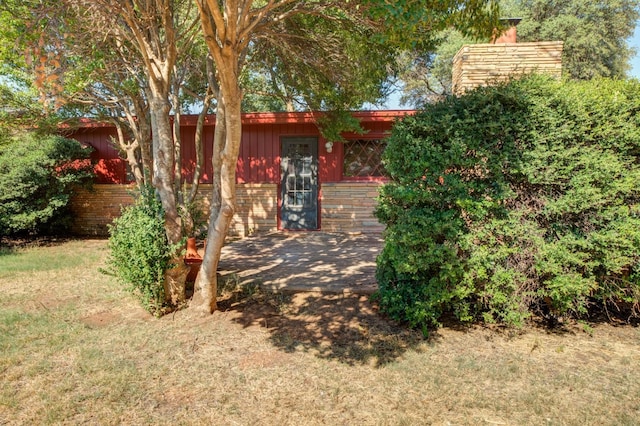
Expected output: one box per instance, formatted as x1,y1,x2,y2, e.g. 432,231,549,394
70,111,413,236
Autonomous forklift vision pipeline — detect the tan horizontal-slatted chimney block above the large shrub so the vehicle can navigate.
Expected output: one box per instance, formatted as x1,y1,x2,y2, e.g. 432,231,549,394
452,41,563,95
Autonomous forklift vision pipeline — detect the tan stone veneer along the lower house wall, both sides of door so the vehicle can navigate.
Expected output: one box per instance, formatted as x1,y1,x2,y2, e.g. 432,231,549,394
71,182,384,237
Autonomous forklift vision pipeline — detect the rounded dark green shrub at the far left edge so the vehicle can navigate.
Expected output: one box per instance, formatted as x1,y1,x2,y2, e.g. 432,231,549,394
0,133,93,236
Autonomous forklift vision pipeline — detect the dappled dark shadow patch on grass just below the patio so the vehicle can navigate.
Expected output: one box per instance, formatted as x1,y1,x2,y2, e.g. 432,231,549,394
219,280,424,367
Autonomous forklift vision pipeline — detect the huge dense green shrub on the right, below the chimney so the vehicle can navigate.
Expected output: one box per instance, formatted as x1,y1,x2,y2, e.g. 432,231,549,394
376,76,640,327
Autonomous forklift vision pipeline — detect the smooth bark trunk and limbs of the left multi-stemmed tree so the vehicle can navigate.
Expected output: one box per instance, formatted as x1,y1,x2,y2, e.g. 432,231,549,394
65,0,204,306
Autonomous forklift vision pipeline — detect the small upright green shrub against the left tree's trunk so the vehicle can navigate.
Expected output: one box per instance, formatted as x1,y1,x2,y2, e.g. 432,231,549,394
104,186,172,315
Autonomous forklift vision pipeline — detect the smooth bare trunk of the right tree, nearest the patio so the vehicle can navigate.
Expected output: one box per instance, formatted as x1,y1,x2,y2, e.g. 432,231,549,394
191,0,262,313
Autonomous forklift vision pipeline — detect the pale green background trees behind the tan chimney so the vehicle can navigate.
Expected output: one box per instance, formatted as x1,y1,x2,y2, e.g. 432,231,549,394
401,0,640,107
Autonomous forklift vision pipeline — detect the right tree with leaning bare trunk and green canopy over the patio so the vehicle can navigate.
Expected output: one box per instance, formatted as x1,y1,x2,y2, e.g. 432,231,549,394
192,0,495,312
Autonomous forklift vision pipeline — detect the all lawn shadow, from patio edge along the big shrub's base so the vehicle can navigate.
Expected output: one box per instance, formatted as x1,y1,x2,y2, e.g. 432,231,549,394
218,284,638,367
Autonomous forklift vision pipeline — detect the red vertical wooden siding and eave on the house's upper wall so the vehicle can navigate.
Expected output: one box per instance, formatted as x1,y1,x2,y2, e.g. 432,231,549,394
71,111,411,183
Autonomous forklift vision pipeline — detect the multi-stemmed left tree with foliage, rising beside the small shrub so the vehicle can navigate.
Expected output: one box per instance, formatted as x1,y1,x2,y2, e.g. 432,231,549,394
55,0,230,306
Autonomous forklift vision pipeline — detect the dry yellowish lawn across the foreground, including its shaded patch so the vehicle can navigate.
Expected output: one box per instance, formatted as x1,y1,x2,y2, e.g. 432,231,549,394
0,241,640,425
